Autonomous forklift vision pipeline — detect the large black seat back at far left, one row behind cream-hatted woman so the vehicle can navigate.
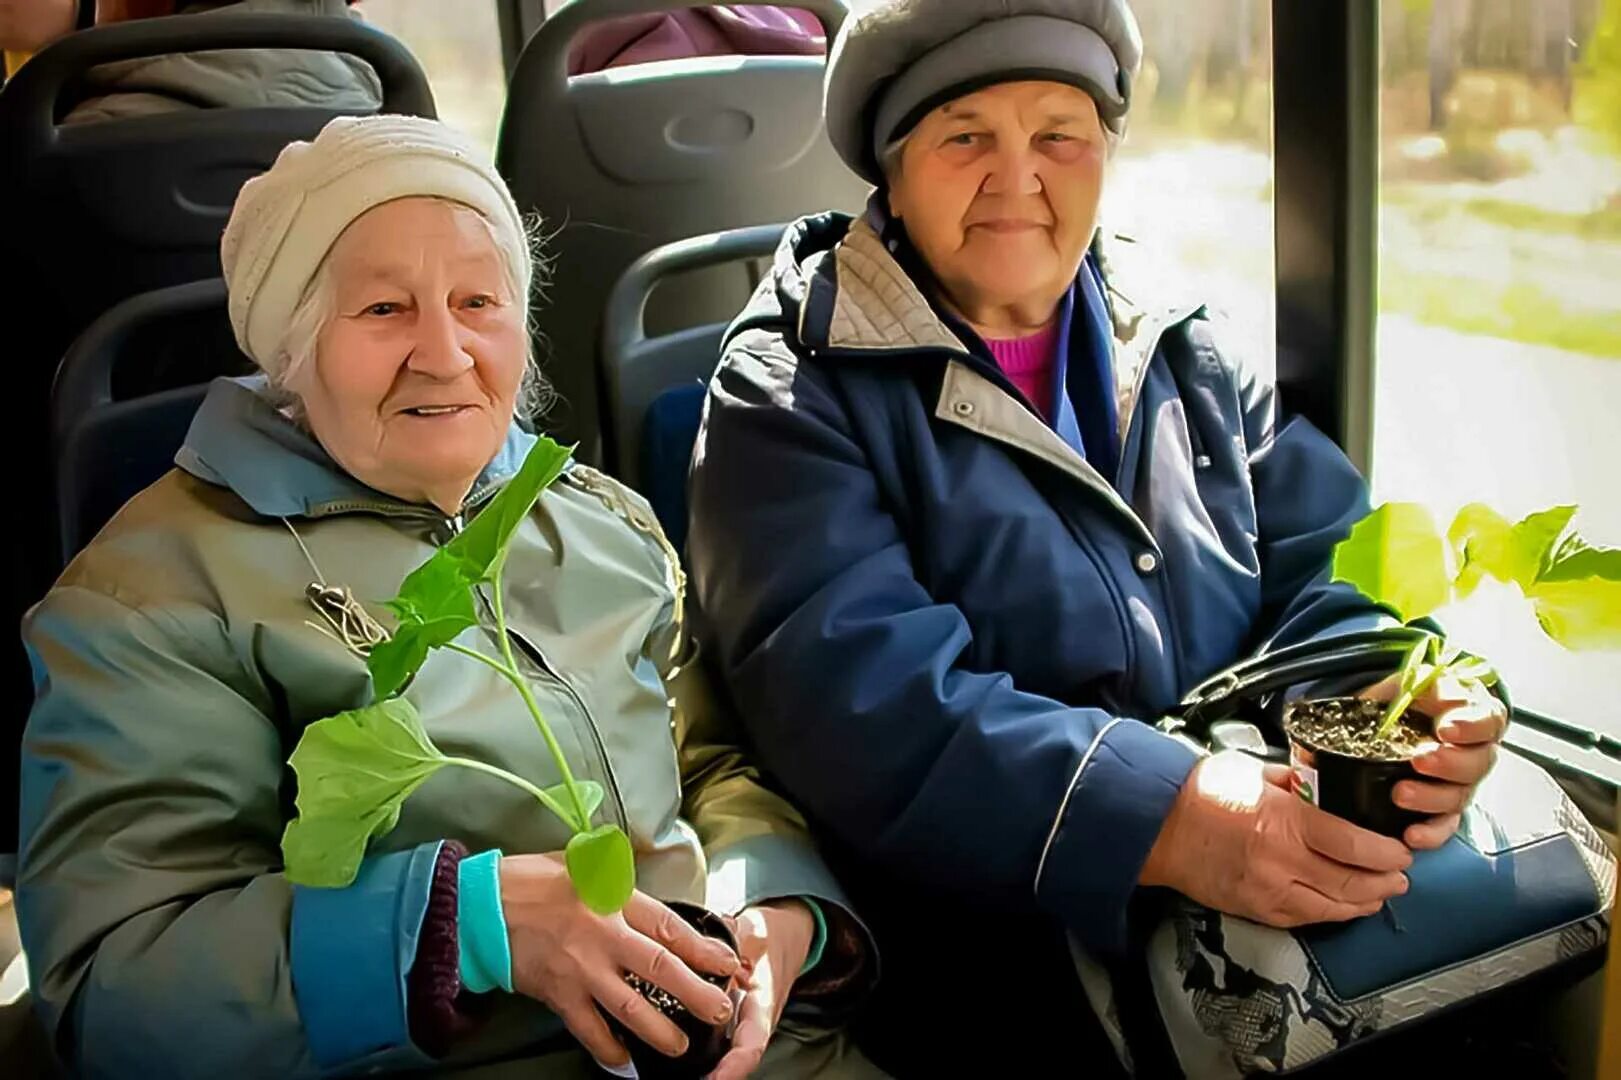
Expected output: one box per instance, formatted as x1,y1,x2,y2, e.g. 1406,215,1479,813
0,11,434,848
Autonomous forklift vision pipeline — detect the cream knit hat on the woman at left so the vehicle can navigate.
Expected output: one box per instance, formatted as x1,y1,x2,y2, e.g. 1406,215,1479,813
219,115,533,368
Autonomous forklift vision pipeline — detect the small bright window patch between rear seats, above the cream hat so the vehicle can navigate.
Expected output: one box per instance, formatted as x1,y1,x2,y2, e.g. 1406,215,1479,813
360,0,506,154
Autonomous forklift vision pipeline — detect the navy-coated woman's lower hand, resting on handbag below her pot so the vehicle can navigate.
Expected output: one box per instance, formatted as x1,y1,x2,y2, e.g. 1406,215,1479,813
1140,751,1412,929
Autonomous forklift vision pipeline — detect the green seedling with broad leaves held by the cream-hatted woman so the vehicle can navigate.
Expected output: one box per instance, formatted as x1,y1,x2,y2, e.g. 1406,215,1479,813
282,438,635,915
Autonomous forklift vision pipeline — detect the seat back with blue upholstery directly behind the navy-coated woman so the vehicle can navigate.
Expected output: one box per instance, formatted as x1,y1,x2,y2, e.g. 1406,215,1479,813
600,225,785,551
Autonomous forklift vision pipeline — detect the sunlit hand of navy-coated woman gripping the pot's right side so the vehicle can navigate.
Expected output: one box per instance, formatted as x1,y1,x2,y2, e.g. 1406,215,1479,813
1362,676,1509,850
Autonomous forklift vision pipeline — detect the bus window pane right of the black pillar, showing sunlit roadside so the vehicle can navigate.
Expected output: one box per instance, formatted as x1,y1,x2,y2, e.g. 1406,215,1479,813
1373,0,1621,735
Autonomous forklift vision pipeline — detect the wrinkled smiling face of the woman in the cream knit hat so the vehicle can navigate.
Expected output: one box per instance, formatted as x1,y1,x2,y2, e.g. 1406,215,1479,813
289,198,527,511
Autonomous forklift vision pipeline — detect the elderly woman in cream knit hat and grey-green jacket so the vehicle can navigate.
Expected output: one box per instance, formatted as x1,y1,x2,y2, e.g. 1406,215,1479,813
18,117,875,1080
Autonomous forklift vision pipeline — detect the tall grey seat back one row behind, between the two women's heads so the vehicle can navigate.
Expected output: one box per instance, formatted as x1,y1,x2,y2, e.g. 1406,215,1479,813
496,0,867,462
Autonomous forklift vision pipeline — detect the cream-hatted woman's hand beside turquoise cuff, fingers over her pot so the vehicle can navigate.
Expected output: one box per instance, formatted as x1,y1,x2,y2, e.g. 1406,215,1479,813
501,855,742,1067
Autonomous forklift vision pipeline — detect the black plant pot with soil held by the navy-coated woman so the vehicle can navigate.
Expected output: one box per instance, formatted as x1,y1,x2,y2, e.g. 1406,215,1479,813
1284,697,1431,838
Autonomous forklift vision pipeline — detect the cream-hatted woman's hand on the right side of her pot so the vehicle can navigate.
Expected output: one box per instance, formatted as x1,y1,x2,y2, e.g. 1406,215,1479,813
710,900,815,1080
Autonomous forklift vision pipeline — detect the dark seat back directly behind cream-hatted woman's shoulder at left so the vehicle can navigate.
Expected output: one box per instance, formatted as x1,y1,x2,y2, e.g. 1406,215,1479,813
50,277,239,564
